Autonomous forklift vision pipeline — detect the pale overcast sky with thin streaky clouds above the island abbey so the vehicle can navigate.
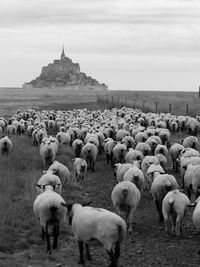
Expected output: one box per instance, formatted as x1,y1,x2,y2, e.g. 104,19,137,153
0,0,200,91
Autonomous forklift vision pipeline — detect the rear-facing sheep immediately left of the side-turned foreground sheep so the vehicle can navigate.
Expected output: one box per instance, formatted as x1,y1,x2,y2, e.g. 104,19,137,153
33,190,67,253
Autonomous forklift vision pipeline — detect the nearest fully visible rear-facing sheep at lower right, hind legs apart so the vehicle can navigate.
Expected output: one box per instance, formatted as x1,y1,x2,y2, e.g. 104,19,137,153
162,189,190,236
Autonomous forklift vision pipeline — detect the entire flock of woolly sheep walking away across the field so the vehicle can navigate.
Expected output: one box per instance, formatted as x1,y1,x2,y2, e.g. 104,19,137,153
0,107,200,266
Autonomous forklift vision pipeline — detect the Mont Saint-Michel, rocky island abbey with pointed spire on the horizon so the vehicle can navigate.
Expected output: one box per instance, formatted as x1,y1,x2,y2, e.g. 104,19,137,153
23,47,108,90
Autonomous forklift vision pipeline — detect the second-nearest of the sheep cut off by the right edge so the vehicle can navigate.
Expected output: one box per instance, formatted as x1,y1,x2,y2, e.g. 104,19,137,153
184,164,200,199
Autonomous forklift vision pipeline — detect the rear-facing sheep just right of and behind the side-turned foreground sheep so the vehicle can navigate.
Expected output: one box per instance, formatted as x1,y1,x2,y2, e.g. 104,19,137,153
111,181,141,233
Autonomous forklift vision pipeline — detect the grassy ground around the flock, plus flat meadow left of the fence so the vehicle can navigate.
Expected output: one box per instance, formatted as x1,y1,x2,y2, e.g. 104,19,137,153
0,89,200,267
